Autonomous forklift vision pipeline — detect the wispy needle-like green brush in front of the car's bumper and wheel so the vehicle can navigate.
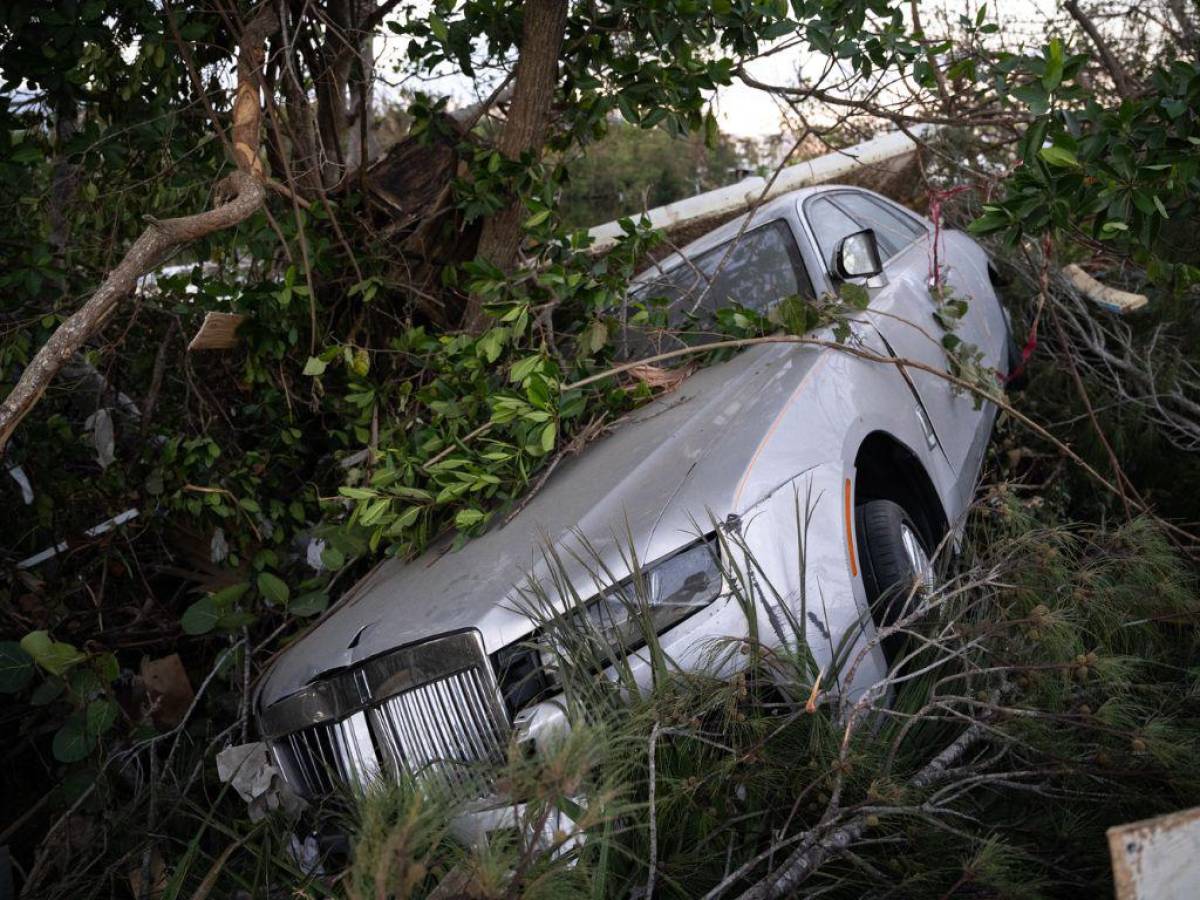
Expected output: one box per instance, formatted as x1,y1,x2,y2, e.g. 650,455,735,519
347,497,1200,898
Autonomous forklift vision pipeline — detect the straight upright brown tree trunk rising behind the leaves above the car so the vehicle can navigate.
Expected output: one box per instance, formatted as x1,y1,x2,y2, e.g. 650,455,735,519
463,0,568,332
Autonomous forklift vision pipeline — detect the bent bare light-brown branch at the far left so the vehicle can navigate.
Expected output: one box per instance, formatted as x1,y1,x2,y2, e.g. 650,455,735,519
0,5,277,457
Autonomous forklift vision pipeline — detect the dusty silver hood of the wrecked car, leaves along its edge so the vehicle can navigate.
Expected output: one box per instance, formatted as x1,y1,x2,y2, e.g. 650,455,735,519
259,344,820,706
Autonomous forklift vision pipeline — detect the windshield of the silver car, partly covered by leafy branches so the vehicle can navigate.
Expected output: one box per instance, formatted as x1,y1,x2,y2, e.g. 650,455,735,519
609,220,814,359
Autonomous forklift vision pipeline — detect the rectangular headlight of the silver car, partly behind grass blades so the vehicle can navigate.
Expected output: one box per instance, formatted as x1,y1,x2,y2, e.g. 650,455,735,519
494,536,721,714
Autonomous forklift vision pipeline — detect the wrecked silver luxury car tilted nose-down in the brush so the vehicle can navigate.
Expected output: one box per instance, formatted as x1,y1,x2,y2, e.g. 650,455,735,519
256,186,1012,797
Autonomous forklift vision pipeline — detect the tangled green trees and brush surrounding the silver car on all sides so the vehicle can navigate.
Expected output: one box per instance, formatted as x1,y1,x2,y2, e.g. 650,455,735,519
0,0,1200,896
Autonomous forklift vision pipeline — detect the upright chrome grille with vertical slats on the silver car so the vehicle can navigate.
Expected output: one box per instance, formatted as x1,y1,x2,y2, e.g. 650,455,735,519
260,632,509,797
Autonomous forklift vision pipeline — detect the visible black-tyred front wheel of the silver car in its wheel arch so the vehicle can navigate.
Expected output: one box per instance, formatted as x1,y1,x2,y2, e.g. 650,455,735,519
856,500,934,662
